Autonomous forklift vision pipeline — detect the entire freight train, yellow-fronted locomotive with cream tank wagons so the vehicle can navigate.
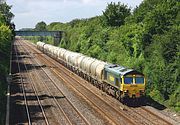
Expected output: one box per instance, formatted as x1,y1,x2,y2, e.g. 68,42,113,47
37,42,145,101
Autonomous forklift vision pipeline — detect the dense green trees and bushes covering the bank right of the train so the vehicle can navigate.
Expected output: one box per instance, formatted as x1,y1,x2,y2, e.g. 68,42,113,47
33,0,180,111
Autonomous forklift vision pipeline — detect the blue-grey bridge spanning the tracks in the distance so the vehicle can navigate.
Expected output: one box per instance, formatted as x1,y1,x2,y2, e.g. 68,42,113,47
15,31,63,46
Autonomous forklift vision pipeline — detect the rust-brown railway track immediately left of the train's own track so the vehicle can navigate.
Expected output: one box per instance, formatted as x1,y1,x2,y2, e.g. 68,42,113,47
22,40,137,125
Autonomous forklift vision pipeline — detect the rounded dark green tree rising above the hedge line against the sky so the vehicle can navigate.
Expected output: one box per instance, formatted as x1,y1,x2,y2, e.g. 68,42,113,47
103,2,131,26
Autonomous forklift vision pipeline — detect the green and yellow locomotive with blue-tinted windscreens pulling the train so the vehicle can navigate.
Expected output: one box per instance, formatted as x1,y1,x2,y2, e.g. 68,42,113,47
104,64,145,99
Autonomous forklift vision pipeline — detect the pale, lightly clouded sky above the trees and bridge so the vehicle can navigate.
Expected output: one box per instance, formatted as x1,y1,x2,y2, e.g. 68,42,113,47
6,0,143,29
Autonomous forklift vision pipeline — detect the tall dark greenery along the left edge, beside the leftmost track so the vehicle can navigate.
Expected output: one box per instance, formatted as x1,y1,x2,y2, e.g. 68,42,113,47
0,3,14,125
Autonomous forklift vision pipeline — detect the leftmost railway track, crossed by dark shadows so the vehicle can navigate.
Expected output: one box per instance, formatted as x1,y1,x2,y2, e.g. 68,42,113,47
11,40,49,125
